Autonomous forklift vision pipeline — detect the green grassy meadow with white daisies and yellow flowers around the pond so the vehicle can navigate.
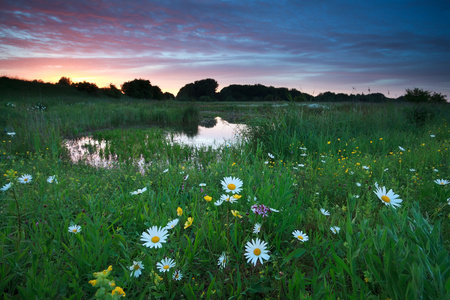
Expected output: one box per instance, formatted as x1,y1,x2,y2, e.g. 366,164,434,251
0,92,450,299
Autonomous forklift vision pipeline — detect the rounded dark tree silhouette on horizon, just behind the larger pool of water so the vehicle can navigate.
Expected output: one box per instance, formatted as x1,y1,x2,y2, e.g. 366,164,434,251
177,78,219,101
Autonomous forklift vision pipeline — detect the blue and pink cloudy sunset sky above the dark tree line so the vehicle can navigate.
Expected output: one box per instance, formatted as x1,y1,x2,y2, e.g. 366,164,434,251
0,0,450,99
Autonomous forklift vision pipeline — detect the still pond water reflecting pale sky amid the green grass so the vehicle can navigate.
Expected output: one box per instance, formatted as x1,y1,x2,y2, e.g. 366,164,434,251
64,117,246,168
